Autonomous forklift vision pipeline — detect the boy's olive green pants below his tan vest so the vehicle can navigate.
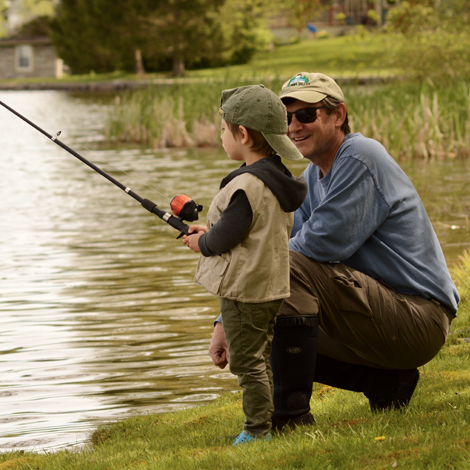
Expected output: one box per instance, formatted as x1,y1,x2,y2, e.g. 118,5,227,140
220,298,282,437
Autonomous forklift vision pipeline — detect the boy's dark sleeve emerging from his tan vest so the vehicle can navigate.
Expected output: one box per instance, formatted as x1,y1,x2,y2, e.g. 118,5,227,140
198,189,253,256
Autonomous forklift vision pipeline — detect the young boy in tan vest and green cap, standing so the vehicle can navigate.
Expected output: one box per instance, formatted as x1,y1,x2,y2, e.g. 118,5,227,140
183,85,307,445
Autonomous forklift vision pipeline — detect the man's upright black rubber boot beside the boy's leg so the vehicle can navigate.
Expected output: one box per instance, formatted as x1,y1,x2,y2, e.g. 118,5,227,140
271,316,318,431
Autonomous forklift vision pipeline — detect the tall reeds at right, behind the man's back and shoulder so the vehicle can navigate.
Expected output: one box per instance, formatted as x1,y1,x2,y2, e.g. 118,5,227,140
346,82,470,160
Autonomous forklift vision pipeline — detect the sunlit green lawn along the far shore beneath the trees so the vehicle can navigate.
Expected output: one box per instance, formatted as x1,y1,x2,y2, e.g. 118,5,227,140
0,34,395,87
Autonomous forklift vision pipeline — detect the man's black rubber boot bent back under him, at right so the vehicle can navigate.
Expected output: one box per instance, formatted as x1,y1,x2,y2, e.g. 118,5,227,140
315,354,419,411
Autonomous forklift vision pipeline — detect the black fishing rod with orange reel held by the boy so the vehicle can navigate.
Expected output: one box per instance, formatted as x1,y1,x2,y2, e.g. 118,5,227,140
0,101,202,238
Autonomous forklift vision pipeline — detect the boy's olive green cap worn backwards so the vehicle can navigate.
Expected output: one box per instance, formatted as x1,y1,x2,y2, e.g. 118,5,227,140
220,85,304,160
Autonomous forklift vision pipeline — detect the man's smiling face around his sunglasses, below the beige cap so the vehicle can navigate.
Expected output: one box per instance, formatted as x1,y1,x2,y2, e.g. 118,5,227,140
286,100,336,161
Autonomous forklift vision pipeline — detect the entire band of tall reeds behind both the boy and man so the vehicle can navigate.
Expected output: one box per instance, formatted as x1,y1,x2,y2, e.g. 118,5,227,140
106,77,470,160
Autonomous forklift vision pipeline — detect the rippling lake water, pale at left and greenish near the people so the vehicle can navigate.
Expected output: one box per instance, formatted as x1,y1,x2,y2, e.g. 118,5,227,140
0,91,470,451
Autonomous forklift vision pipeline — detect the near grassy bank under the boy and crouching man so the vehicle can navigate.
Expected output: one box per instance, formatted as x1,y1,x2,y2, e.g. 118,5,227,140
0,253,470,470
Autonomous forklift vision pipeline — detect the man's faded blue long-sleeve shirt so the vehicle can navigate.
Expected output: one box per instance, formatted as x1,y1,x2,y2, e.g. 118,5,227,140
289,133,459,311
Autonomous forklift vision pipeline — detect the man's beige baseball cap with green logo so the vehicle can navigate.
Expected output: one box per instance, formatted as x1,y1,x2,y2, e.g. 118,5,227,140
279,72,344,103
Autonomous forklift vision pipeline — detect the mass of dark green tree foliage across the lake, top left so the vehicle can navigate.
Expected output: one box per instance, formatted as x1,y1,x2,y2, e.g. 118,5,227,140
48,0,268,75
